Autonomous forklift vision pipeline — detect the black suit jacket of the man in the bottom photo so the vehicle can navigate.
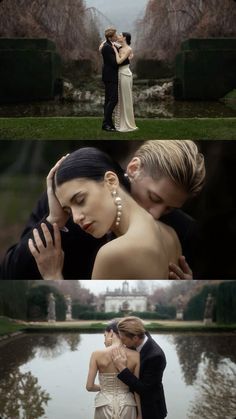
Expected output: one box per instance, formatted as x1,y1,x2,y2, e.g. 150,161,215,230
118,333,167,419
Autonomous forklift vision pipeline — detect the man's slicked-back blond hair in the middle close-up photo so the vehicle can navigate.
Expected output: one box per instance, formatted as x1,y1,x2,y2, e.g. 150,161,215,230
135,140,206,196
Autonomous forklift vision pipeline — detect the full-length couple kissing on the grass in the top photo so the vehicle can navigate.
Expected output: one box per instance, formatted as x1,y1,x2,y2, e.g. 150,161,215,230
99,28,137,132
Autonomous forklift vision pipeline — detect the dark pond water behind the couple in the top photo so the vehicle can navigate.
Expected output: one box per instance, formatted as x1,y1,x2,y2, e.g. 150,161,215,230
0,98,236,118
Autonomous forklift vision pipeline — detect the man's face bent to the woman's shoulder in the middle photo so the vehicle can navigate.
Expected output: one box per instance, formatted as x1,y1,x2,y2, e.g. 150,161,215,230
128,172,188,220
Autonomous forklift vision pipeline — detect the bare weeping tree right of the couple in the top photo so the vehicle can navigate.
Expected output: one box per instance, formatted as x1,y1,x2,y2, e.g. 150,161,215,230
136,0,236,62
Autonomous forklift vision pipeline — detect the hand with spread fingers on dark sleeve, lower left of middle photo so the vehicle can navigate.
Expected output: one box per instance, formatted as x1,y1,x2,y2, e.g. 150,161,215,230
28,223,64,280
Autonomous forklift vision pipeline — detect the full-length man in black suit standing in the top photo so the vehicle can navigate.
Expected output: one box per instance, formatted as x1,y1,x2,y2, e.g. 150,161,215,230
101,28,118,131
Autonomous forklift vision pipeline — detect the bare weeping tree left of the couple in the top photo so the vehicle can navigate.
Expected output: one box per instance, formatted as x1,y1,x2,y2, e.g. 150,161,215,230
0,0,100,66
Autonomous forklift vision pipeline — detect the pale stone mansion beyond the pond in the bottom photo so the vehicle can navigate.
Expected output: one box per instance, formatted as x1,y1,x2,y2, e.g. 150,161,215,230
104,281,147,313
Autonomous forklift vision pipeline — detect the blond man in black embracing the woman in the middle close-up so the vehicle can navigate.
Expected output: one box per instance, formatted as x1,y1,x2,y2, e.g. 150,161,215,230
1,140,205,279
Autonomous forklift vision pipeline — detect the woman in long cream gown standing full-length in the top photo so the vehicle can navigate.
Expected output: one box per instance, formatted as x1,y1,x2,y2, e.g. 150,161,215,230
113,32,138,132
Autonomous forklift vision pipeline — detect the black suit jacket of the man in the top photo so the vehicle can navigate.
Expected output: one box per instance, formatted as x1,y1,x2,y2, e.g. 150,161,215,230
102,41,118,84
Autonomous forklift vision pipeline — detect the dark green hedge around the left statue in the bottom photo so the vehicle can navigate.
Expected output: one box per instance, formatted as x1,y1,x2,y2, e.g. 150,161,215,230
28,284,66,321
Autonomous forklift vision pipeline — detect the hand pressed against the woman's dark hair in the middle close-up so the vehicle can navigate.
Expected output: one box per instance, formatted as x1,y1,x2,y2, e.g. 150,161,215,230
47,154,69,228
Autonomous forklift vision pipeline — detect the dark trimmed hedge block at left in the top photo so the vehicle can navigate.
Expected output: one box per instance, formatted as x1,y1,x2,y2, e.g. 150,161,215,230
0,39,62,103
